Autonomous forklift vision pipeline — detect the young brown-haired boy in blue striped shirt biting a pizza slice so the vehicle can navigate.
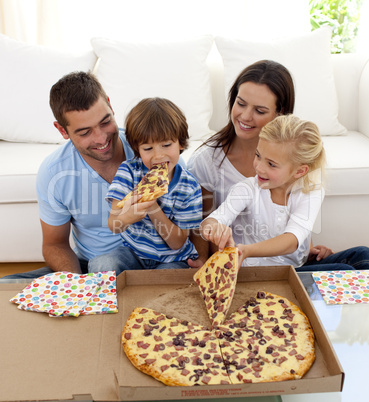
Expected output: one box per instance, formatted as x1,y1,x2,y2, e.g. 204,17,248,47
88,98,202,274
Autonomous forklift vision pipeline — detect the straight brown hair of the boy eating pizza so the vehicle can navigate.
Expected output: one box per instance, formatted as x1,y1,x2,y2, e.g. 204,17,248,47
125,98,189,157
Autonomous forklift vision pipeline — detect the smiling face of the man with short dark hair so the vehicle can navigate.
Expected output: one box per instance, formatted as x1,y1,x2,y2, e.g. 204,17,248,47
55,97,119,163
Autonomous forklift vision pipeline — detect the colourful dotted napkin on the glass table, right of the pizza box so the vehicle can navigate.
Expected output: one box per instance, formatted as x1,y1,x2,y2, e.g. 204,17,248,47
313,271,369,304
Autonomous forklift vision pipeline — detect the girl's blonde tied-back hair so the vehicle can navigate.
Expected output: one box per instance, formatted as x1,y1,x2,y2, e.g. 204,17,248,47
259,114,325,193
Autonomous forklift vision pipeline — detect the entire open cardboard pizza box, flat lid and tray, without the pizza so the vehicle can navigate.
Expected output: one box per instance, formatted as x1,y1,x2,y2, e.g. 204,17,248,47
0,267,344,401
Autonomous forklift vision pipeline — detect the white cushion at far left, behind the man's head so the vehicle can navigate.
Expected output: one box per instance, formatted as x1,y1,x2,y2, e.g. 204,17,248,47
0,35,96,143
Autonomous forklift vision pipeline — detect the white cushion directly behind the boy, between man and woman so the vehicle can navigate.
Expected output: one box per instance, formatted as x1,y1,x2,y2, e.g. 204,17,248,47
91,36,213,139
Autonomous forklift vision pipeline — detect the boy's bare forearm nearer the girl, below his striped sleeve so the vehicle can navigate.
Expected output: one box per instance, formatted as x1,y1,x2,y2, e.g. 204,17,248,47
148,201,189,250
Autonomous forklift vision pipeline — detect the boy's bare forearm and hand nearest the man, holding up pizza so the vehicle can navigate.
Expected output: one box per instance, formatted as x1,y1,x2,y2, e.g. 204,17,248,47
108,194,155,233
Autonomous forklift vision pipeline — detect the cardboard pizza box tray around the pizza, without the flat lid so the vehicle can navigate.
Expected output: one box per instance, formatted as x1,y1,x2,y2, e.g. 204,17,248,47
117,266,344,401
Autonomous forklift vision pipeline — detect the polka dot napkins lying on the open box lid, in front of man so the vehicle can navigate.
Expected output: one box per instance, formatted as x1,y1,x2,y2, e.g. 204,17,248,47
10,271,118,317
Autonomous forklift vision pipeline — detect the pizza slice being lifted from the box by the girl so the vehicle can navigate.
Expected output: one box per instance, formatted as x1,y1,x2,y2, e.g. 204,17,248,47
193,247,239,327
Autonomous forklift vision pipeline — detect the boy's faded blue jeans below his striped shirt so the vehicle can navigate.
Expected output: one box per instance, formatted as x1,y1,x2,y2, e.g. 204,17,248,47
88,246,189,275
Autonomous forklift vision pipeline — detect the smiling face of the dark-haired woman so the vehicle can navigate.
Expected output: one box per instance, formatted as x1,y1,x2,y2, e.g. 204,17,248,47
231,82,277,139
